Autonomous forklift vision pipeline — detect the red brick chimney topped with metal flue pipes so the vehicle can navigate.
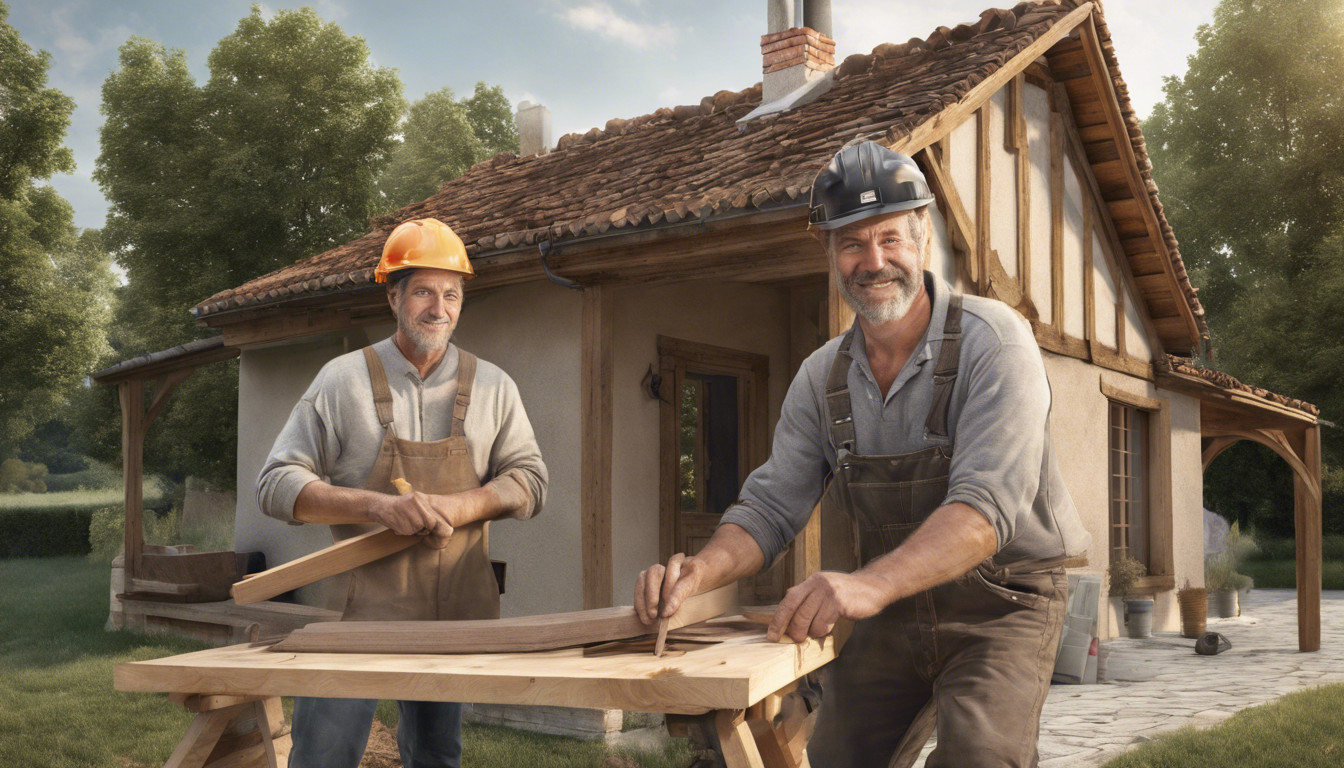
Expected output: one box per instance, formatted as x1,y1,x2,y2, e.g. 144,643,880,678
761,0,836,104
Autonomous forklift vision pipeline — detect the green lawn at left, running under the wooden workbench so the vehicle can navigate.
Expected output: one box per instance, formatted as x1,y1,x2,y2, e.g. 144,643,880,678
0,557,691,768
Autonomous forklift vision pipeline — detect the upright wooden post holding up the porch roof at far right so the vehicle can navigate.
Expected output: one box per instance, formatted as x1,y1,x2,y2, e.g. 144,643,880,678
1293,426,1321,651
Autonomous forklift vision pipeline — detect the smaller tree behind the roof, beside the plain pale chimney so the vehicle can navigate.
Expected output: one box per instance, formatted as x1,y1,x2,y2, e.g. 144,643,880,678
378,82,517,211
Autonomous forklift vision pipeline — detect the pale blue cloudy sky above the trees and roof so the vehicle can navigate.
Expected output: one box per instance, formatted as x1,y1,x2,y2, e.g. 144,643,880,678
7,0,1216,227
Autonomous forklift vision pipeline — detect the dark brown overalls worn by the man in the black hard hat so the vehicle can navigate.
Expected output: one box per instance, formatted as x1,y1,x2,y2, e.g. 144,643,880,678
808,293,1067,768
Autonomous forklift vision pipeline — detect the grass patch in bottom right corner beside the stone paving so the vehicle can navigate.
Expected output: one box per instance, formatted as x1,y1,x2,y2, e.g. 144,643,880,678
1105,685,1344,768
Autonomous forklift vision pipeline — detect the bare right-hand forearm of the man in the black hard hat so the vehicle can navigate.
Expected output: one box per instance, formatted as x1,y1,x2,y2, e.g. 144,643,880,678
855,503,999,604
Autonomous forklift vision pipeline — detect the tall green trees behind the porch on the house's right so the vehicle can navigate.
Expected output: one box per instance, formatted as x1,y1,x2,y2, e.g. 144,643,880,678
1144,0,1344,531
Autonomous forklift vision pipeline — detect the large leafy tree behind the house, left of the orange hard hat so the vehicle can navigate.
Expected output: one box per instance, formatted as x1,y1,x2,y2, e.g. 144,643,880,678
89,7,406,484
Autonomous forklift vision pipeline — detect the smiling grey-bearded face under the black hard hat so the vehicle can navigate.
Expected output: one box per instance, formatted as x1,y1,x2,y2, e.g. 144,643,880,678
827,211,927,324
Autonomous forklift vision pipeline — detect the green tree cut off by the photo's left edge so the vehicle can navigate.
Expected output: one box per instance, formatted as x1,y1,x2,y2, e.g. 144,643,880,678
0,3,112,457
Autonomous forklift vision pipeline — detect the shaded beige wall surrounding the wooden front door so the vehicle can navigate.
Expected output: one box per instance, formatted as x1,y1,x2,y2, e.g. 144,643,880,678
612,282,789,605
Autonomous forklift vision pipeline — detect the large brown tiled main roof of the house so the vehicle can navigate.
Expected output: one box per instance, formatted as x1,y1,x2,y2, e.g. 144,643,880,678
194,0,1203,344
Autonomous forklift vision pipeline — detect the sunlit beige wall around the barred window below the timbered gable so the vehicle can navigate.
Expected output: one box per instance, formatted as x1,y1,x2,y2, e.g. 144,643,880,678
1042,351,1204,638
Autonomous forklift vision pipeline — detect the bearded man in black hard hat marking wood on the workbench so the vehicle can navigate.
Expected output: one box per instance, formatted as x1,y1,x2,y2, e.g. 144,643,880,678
634,141,1091,768
